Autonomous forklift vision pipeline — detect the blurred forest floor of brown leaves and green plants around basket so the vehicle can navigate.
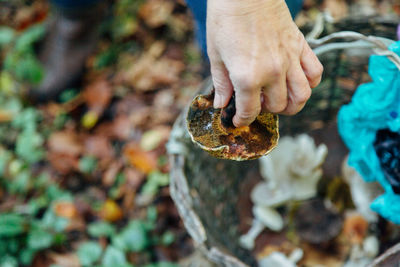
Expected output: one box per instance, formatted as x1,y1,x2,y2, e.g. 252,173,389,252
0,0,398,267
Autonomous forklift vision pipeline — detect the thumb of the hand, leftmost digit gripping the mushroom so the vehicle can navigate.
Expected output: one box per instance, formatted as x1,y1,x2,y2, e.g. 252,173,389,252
211,62,233,108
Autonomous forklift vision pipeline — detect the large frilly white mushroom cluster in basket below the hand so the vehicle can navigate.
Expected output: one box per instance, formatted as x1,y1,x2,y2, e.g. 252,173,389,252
253,134,328,202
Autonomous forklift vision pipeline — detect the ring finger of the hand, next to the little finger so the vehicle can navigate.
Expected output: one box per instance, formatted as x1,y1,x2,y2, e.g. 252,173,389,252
281,64,311,115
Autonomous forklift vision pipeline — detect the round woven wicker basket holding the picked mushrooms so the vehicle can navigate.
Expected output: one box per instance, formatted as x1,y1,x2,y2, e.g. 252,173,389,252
168,17,398,267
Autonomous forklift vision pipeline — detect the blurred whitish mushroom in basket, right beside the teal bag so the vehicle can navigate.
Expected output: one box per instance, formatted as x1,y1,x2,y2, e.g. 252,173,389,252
342,157,383,222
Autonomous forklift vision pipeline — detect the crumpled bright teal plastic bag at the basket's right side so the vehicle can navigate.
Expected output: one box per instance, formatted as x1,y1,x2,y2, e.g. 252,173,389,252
338,41,400,224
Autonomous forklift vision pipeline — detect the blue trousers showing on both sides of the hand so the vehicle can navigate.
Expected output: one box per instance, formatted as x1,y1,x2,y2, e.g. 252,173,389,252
186,0,303,55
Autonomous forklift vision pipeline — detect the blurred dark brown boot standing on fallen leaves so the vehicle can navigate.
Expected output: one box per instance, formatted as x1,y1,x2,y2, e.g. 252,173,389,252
29,1,106,102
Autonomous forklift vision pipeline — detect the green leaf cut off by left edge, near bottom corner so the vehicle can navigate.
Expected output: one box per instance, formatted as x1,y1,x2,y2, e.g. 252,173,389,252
0,213,25,238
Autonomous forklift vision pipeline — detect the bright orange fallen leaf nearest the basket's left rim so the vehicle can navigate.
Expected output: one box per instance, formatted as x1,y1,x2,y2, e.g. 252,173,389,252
124,143,157,174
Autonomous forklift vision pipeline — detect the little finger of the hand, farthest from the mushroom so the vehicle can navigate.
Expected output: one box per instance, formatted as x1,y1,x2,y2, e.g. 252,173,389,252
300,44,324,88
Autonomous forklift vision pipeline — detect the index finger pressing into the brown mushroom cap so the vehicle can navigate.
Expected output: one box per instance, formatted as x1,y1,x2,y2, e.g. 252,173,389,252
232,74,261,127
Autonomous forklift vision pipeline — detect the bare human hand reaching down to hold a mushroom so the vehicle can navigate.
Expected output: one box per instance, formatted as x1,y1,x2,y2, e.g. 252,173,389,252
207,0,323,127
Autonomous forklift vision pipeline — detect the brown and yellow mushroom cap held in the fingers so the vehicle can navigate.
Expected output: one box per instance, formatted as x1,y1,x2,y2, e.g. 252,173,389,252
186,92,279,161
